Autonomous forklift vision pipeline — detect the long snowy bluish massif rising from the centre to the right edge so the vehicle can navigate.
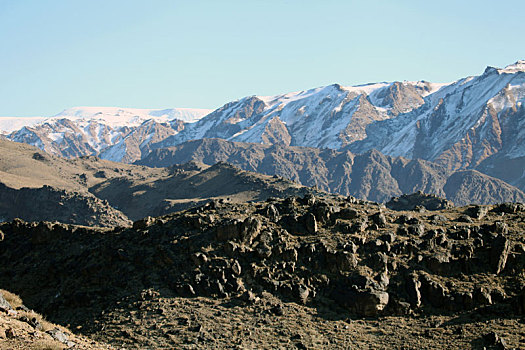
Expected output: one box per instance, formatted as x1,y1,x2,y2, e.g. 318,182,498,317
146,61,525,189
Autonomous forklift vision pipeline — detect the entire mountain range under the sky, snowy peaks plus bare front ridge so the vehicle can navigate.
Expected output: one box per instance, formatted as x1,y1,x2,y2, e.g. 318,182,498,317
0,61,525,204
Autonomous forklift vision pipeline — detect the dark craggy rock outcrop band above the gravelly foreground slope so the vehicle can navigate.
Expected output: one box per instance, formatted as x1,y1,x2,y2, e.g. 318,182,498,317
0,194,524,322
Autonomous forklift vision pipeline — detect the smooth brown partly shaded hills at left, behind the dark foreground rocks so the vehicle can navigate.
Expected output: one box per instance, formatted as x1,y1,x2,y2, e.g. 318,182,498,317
0,140,311,226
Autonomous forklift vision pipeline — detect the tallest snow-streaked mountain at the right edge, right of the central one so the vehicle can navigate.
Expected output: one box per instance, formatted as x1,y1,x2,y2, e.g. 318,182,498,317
350,61,525,165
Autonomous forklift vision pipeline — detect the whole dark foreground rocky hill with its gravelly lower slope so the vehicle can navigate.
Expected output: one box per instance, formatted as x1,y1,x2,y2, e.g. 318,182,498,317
0,194,525,349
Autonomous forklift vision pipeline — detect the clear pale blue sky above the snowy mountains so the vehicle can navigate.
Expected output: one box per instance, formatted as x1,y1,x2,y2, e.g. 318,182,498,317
0,0,525,116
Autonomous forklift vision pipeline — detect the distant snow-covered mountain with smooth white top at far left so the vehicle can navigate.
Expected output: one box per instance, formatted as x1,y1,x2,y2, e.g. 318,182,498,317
0,107,210,162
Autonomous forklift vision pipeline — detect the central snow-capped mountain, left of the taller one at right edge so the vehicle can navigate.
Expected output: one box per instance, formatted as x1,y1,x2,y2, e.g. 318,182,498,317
155,82,443,149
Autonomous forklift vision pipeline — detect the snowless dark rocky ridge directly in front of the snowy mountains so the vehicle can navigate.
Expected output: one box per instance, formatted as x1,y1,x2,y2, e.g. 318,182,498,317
136,139,525,205
